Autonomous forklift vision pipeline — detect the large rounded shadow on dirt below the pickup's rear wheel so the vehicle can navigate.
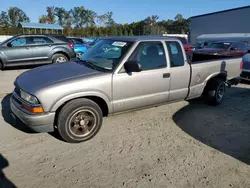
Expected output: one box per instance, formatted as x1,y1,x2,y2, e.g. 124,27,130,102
173,87,250,165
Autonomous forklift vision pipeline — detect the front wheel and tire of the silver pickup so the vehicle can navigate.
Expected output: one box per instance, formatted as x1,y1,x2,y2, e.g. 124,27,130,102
57,99,103,143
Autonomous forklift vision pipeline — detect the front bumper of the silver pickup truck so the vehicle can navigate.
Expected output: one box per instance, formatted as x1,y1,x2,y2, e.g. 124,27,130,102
10,96,55,132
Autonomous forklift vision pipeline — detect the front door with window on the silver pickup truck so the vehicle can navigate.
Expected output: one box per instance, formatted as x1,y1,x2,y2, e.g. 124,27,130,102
112,41,170,113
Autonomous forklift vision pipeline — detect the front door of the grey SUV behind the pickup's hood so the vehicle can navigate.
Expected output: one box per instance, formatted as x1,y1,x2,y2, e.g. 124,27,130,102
3,37,33,65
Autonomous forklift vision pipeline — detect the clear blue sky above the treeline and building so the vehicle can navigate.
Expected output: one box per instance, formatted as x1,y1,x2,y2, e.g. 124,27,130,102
0,0,250,24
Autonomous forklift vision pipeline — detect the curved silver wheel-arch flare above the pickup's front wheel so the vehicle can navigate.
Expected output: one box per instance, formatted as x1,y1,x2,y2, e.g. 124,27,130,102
50,91,113,113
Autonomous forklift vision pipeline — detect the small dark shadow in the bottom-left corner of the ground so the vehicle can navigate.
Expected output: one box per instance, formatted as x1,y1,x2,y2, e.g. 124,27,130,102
0,154,16,188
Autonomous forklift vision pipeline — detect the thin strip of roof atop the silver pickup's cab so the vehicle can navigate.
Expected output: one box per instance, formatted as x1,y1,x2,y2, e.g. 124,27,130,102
98,36,173,42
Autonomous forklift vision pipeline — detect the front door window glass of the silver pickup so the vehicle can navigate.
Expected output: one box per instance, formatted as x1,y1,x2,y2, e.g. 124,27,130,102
129,42,167,71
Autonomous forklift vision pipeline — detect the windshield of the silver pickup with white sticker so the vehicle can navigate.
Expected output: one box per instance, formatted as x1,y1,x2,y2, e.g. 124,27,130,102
80,40,133,71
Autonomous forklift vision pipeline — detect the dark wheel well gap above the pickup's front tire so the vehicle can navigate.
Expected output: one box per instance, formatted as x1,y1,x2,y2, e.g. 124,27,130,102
54,96,109,125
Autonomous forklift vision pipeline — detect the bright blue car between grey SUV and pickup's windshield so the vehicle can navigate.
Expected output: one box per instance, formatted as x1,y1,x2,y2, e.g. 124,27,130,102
68,37,90,58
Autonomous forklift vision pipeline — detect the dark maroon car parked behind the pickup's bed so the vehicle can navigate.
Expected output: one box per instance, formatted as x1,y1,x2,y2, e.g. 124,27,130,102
192,41,250,61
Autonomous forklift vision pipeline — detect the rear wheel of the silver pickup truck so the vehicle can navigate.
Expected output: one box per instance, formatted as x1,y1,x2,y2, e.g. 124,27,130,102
208,78,226,106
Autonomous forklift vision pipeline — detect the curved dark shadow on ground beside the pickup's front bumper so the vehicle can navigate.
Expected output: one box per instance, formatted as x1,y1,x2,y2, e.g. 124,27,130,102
1,94,36,133
